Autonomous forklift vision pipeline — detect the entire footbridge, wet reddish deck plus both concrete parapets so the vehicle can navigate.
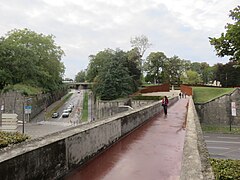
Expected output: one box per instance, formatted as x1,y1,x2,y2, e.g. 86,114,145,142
0,97,214,180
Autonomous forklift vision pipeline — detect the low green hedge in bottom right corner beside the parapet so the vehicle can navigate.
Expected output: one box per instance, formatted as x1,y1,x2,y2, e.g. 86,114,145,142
210,159,240,180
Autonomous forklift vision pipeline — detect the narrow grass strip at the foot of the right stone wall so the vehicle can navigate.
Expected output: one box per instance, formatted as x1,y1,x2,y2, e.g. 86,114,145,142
201,124,240,134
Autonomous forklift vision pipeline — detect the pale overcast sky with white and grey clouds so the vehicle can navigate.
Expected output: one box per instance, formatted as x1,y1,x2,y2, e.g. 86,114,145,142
0,0,239,79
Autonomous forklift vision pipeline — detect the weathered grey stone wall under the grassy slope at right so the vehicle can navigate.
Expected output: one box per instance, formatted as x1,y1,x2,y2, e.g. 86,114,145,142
195,88,240,125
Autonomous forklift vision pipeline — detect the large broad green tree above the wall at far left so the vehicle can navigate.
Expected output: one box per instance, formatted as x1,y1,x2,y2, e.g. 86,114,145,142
0,29,64,91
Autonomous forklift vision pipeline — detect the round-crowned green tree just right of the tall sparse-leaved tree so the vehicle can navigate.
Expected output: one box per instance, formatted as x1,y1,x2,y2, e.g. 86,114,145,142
144,52,167,83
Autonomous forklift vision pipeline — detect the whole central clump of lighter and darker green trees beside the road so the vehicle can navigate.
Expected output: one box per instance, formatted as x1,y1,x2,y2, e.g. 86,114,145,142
87,49,140,100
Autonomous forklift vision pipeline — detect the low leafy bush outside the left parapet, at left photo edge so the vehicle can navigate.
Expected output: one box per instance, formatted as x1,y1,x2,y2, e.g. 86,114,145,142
0,131,29,148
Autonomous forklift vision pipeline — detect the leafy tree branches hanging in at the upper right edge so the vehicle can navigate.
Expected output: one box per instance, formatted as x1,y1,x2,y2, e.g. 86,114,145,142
209,6,240,62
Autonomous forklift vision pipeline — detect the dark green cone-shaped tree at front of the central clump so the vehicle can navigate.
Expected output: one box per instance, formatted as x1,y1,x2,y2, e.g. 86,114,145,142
93,51,133,100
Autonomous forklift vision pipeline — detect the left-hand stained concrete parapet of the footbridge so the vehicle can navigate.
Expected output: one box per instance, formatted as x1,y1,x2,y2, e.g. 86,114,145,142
0,98,177,180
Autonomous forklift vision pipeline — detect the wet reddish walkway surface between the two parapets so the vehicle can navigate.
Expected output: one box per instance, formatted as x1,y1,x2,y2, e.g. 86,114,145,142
65,99,188,180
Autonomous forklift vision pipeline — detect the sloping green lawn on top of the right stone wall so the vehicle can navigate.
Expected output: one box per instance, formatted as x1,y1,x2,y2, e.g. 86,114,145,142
193,87,235,103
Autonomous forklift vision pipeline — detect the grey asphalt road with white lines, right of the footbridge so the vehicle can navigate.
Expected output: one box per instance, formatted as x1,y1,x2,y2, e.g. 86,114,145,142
204,133,240,160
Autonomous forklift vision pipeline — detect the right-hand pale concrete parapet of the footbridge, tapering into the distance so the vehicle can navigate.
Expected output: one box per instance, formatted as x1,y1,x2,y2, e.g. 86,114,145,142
180,97,214,180
